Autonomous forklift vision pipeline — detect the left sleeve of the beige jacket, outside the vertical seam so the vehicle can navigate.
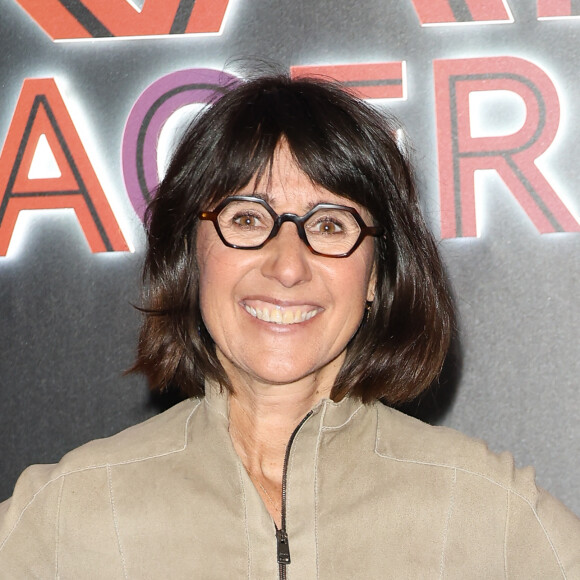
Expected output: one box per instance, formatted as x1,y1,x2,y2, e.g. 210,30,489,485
0,463,124,580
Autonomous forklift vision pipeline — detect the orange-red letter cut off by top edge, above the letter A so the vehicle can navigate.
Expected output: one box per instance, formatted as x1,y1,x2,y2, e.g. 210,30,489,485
17,0,229,40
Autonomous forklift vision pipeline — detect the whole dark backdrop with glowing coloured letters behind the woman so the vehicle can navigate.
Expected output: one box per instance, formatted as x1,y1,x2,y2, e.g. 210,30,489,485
0,0,580,512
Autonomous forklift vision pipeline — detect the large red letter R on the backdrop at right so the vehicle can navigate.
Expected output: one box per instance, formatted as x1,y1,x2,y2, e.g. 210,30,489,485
433,57,580,238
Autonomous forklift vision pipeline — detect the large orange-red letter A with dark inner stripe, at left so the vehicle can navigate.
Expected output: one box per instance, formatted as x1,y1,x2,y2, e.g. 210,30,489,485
0,79,129,256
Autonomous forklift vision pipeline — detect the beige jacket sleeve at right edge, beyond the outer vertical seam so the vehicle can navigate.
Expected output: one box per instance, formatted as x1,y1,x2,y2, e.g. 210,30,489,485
505,489,580,580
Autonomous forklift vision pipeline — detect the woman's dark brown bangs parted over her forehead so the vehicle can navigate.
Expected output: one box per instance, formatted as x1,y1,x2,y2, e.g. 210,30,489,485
202,77,384,215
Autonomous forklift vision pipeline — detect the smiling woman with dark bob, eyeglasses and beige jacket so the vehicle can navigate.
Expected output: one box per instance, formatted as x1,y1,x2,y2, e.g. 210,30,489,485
0,77,580,579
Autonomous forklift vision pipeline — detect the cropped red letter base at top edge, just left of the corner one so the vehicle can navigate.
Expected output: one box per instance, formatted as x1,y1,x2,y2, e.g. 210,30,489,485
413,0,513,26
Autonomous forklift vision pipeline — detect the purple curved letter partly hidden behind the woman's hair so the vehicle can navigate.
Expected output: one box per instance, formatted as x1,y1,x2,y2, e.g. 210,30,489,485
121,68,239,221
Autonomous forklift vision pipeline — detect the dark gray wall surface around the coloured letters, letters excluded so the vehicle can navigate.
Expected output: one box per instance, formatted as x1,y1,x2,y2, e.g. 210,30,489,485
0,0,580,513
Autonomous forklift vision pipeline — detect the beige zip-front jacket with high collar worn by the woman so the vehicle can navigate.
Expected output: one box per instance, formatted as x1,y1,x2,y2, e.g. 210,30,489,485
0,394,580,580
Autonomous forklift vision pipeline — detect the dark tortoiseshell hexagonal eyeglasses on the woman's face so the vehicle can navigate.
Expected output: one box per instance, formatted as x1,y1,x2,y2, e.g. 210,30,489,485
199,196,383,258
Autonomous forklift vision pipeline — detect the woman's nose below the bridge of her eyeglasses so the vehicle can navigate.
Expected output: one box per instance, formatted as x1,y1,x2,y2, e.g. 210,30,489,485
261,222,312,288
